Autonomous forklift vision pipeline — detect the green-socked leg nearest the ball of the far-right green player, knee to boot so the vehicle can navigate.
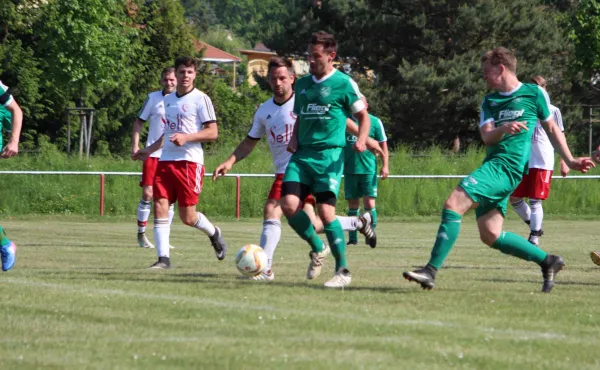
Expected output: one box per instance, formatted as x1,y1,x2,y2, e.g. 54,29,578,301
403,185,476,289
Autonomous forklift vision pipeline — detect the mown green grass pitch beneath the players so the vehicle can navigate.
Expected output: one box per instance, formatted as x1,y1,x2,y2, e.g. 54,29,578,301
0,217,600,369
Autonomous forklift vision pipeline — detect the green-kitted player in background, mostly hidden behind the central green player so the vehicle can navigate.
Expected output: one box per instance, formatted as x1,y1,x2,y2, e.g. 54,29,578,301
344,96,390,248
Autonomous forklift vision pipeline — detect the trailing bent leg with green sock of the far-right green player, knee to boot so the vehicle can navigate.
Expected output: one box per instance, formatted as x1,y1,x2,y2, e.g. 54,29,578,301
477,209,565,293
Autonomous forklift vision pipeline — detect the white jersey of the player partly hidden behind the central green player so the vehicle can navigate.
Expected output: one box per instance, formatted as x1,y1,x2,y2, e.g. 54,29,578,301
248,95,296,174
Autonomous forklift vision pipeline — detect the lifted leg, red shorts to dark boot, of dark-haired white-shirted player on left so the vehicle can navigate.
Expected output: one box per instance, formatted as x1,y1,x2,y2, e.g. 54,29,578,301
177,161,227,261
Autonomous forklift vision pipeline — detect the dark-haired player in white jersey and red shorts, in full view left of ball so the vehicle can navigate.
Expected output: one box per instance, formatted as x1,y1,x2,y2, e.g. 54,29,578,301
134,57,227,269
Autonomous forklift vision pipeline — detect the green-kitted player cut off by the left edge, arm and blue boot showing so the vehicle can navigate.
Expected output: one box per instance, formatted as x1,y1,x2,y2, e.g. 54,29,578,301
0,81,23,271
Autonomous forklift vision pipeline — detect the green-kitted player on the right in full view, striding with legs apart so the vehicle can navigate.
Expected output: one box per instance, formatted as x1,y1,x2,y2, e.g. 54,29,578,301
403,47,594,293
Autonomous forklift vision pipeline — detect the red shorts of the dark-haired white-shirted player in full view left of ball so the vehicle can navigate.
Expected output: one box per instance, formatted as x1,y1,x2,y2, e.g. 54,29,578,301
153,161,204,207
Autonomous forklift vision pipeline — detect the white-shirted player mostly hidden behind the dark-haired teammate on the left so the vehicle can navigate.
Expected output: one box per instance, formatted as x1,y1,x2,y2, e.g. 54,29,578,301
131,67,177,248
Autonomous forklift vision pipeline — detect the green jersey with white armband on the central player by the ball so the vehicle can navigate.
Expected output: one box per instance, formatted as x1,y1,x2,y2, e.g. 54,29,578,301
294,69,365,150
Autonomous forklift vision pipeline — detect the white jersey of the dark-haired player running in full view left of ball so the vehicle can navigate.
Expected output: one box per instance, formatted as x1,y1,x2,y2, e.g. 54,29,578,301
160,88,217,165
